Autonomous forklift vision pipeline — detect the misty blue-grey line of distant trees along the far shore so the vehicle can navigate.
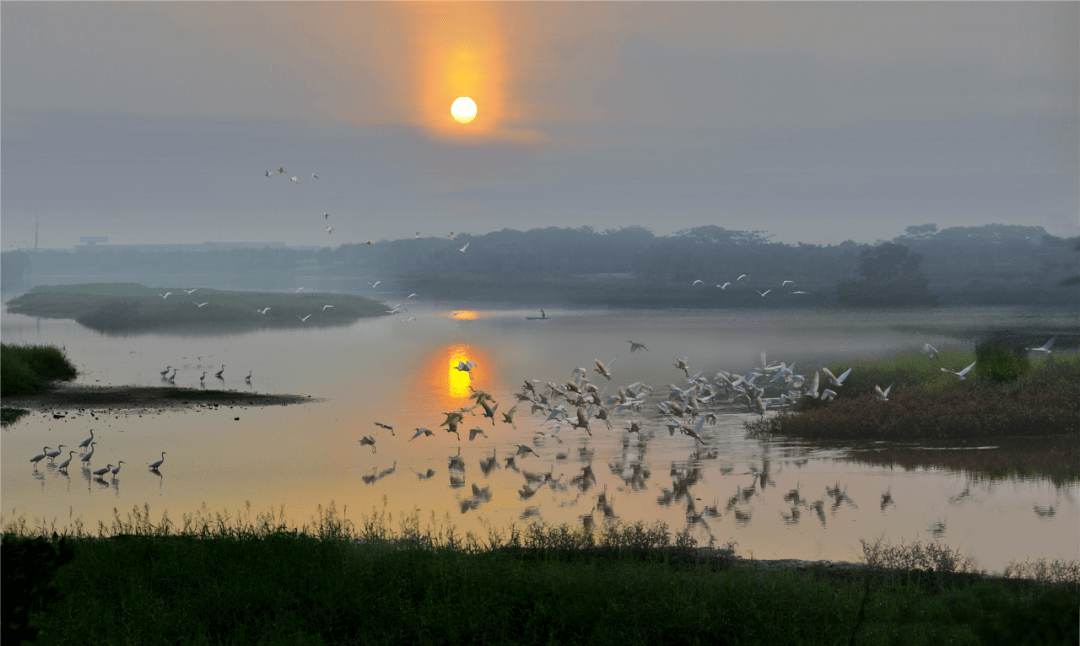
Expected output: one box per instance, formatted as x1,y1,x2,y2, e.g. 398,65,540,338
3,224,1080,305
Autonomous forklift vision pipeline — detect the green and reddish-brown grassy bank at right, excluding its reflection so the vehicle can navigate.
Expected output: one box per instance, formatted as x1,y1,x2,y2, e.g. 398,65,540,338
746,351,1080,445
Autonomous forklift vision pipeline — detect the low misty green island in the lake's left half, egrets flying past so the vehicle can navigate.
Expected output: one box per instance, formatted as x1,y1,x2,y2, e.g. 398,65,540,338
8,283,386,333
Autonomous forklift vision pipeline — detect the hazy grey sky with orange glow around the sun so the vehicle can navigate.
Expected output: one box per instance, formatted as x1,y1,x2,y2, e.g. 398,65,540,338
0,1,1080,248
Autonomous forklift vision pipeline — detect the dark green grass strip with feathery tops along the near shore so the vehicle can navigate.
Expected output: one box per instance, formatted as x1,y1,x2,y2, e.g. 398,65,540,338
3,503,1080,646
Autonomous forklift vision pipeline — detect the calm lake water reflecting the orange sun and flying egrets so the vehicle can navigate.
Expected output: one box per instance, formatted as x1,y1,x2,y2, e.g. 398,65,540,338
2,300,1080,571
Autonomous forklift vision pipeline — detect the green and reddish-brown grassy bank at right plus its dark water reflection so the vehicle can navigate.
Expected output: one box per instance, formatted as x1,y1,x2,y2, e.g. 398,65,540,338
746,349,1080,484
